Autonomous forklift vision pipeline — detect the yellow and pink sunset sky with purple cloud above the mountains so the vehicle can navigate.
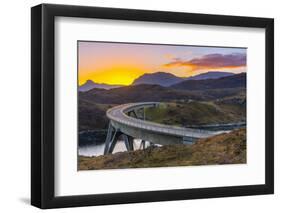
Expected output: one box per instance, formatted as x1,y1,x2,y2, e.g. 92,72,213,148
78,41,247,85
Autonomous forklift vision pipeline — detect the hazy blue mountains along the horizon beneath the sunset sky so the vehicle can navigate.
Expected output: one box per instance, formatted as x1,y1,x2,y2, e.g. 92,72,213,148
79,71,234,92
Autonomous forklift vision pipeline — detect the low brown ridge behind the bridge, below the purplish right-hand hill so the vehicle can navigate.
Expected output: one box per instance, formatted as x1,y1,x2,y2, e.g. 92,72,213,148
79,84,244,104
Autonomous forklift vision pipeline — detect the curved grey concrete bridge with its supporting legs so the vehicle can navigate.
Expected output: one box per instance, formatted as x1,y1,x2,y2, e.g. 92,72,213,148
104,102,221,154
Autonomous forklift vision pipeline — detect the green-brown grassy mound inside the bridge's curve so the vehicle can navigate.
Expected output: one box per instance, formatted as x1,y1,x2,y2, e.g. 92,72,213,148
145,101,246,126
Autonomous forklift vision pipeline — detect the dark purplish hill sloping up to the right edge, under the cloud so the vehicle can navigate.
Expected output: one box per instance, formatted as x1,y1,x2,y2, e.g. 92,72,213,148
168,73,246,91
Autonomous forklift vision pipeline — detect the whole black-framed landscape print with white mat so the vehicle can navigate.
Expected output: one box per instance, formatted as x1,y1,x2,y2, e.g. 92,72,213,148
31,4,274,208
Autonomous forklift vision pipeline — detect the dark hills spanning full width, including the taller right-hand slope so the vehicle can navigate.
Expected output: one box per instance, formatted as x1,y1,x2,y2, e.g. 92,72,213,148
79,73,246,104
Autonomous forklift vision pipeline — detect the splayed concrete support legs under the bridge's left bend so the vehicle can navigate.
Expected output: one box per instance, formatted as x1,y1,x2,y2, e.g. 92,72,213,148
104,122,134,155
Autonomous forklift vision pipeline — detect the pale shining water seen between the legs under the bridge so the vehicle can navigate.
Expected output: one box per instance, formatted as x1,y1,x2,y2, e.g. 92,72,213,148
78,139,149,156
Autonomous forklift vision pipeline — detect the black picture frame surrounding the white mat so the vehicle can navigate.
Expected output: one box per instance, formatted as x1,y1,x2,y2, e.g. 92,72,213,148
31,4,274,209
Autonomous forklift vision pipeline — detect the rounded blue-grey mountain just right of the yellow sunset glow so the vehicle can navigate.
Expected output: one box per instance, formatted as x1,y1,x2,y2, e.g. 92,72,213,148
132,72,184,87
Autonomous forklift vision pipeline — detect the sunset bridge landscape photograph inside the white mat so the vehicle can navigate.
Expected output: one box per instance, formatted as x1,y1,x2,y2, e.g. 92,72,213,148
77,41,247,171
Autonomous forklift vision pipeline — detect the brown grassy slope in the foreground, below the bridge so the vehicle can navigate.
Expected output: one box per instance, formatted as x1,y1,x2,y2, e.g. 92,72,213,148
78,128,246,170
